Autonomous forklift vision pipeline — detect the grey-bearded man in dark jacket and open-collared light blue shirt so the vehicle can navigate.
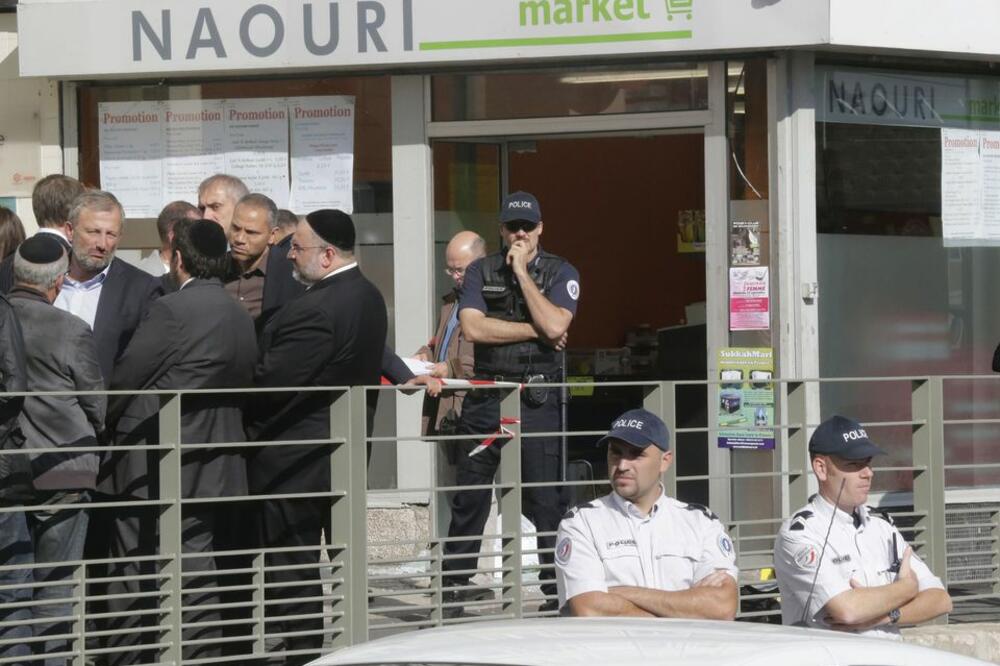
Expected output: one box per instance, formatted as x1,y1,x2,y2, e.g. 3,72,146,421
55,191,160,382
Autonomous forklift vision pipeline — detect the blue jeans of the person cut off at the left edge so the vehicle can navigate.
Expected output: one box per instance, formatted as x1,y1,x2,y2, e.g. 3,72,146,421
0,511,34,657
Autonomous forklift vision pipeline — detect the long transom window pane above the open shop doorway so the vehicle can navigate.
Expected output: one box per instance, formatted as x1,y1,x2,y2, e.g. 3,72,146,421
431,63,708,121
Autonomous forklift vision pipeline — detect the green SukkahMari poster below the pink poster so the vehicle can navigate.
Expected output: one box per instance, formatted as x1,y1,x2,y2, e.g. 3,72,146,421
718,347,774,450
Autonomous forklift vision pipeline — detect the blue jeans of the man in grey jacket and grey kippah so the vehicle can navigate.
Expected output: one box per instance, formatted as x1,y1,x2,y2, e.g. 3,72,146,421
28,490,90,666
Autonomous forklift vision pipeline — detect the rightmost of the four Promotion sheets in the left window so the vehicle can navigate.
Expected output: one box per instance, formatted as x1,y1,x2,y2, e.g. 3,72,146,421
288,96,354,214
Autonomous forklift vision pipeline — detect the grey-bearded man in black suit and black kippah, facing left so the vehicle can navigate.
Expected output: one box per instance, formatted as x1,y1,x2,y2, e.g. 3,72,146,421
247,210,387,663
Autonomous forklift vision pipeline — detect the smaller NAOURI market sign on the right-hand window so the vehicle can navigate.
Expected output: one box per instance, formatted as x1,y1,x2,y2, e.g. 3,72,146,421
816,67,1000,127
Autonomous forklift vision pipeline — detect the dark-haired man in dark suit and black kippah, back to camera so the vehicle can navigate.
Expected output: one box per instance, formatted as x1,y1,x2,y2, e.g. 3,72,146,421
105,220,257,659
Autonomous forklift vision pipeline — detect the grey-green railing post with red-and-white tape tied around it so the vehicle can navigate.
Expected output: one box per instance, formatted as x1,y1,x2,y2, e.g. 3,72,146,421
498,388,532,618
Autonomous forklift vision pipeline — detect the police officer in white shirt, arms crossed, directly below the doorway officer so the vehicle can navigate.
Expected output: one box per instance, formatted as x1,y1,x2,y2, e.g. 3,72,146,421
555,409,737,620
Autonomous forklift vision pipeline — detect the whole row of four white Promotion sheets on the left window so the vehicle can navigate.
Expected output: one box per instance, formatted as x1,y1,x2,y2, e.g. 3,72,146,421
98,96,354,217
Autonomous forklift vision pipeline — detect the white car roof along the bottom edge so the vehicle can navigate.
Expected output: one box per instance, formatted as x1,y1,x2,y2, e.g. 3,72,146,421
311,618,987,666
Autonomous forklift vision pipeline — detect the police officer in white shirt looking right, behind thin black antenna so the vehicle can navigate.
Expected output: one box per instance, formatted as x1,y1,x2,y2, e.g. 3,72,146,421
774,416,951,638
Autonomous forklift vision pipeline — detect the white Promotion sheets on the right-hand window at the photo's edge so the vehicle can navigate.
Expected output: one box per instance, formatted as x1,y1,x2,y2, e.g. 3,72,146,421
941,129,1000,247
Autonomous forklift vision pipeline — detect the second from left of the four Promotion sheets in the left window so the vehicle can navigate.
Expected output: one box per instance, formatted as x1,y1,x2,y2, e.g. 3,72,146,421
163,100,226,205
